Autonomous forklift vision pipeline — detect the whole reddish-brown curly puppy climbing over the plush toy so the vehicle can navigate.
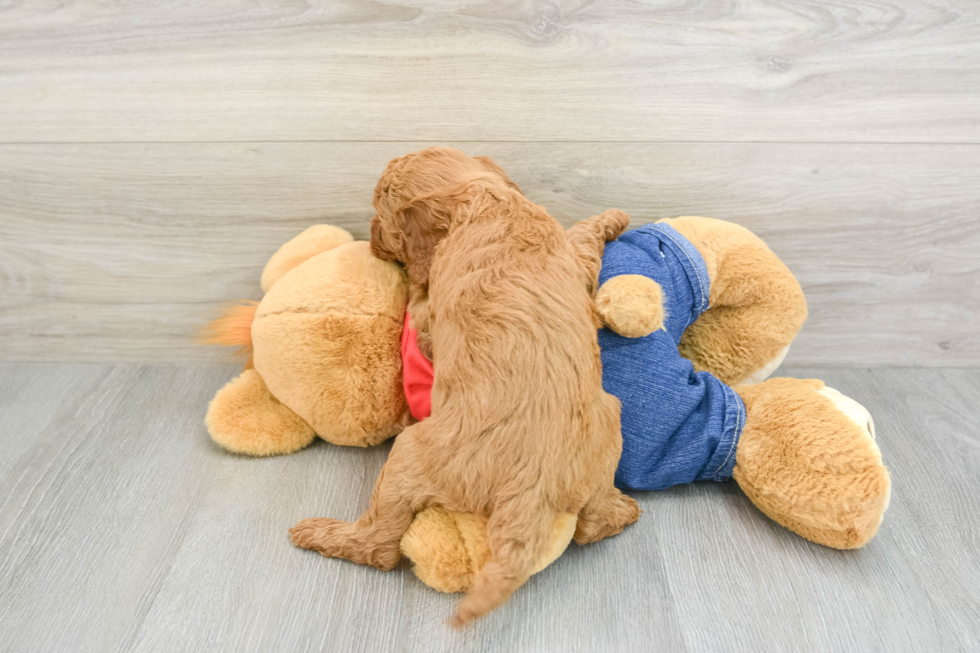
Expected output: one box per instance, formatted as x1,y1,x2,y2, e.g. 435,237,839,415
290,147,639,625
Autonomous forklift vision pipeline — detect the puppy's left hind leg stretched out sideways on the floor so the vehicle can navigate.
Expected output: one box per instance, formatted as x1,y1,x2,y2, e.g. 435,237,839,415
289,423,428,571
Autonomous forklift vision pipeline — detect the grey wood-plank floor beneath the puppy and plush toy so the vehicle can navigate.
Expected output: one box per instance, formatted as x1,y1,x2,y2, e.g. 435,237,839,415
0,363,980,652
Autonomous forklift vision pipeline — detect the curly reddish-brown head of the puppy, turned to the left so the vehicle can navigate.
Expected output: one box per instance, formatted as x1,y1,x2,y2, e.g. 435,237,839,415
371,147,521,286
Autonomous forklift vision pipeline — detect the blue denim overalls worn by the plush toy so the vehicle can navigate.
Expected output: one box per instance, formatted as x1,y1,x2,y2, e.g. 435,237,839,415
599,224,745,490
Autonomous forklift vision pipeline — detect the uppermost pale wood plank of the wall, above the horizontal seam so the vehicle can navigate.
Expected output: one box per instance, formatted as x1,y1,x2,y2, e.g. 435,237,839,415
0,0,980,143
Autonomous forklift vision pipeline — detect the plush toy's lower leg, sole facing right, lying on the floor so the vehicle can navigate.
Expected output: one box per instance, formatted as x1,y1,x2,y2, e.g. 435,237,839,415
733,378,891,549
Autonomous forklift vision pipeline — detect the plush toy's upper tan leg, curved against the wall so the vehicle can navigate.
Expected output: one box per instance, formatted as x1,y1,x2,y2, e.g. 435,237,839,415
664,217,807,385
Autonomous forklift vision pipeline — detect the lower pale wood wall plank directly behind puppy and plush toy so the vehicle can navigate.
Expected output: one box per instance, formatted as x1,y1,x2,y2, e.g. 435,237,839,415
0,143,980,366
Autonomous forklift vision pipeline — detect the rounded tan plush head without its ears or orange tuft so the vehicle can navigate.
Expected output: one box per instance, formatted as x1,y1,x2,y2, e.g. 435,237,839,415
252,242,410,446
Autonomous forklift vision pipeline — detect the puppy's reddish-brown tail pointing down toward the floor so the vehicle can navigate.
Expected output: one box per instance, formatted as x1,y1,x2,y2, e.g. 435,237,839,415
452,495,555,628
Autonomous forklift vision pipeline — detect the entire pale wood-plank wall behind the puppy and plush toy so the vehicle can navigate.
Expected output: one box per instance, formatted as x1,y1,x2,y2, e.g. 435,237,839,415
0,0,980,366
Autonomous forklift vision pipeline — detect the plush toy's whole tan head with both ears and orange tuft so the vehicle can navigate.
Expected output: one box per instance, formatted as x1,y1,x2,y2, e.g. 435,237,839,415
206,225,412,455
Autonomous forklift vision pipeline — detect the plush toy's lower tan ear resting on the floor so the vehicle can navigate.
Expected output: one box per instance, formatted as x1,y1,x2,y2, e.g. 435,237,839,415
204,369,316,456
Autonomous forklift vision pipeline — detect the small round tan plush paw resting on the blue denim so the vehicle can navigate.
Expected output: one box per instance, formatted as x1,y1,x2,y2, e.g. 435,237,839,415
596,274,664,338
